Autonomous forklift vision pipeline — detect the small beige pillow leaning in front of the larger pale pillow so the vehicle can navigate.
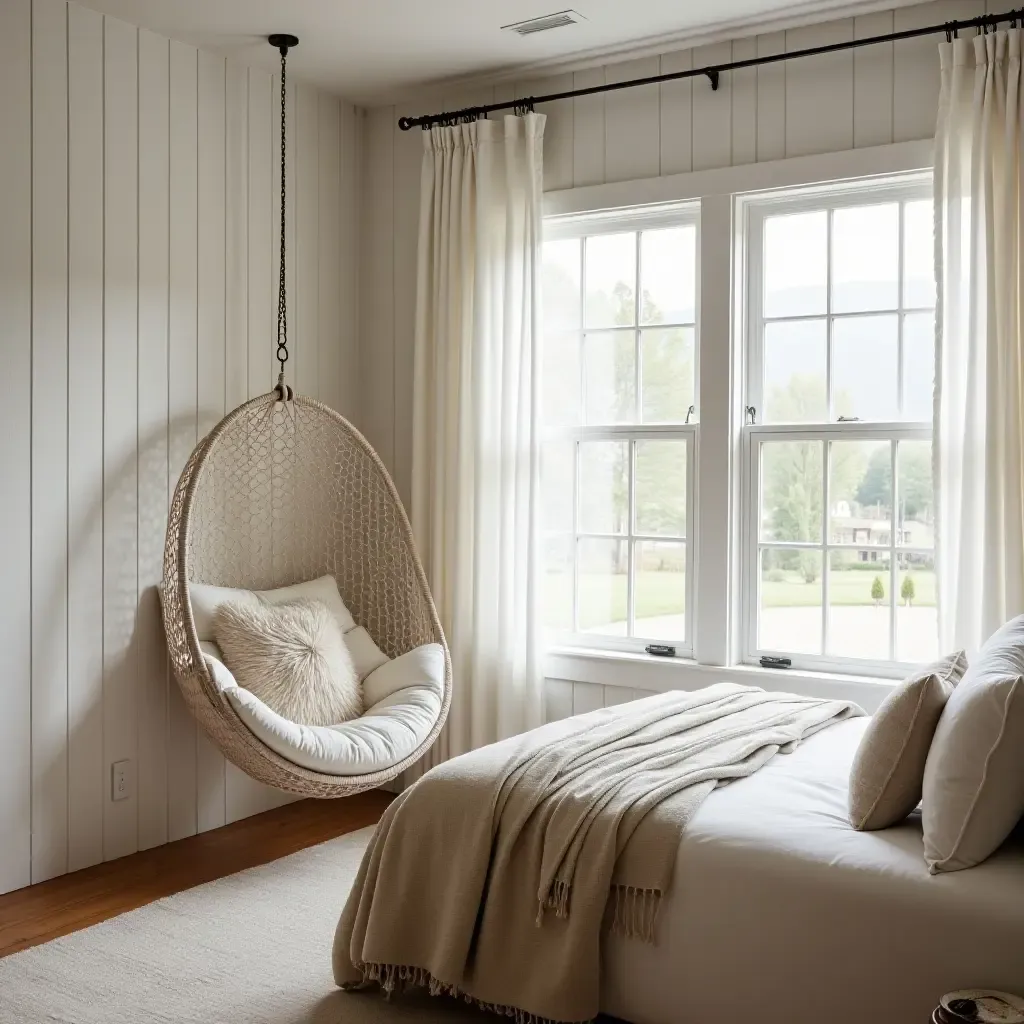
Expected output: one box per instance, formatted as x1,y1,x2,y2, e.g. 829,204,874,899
850,651,967,831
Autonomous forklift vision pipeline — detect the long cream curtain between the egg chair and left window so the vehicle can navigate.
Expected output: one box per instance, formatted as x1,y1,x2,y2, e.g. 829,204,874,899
413,114,545,767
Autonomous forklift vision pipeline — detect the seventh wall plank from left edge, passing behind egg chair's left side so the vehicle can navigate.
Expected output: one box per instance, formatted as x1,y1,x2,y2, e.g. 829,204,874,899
196,52,227,831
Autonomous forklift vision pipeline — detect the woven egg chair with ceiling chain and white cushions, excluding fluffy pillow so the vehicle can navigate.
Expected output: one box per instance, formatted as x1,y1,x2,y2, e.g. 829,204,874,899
162,36,452,798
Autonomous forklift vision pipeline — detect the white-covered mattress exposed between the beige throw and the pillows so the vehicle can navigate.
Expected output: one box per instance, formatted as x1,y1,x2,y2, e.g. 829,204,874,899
601,719,1024,1024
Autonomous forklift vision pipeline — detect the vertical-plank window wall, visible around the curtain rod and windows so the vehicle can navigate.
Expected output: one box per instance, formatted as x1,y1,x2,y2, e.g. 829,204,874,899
359,0,991,718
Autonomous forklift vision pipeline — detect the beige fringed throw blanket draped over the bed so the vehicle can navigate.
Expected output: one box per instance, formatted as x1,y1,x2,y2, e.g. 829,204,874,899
334,683,863,1024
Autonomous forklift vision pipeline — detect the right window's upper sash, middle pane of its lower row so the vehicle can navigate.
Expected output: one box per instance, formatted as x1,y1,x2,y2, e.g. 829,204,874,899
833,315,899,420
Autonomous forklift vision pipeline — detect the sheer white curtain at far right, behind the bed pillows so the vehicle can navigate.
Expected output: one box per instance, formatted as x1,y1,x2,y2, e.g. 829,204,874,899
935,29,1024,650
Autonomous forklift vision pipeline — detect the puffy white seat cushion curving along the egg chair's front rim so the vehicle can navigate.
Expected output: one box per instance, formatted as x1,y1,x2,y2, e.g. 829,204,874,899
200,642,444,775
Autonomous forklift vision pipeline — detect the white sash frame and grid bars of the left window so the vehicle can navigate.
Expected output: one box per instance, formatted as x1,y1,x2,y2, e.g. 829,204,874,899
544,203,700,657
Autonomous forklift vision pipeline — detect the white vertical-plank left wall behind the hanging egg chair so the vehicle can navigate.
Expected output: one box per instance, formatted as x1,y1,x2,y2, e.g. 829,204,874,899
0,0,361,892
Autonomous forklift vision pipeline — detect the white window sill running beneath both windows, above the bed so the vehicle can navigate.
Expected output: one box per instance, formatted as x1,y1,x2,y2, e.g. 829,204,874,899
545,647,898,712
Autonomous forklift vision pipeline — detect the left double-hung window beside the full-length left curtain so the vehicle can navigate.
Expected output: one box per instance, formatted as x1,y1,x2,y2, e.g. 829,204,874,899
542,207,697,652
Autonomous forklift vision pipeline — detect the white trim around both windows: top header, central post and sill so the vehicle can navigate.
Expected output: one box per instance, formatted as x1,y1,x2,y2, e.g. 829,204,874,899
544,140,934,710
